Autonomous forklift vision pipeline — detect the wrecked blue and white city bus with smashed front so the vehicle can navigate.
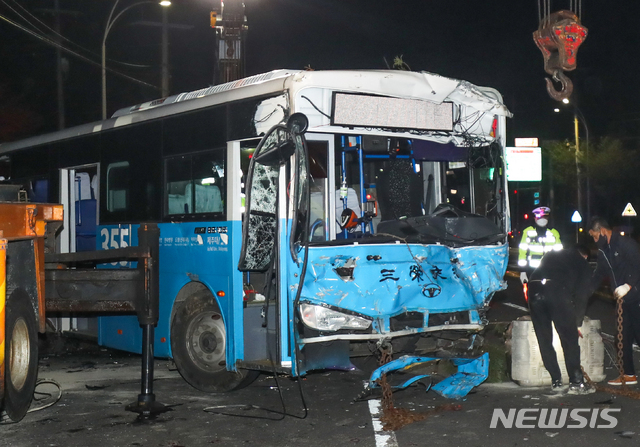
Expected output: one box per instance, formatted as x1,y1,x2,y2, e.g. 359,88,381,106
0,70,510,392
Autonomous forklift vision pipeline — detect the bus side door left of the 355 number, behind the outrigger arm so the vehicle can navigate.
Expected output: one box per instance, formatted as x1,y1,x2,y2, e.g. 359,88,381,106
56,164,100,336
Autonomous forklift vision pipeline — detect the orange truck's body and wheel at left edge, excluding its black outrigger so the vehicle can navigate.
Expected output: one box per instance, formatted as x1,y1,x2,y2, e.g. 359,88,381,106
0,202,63,421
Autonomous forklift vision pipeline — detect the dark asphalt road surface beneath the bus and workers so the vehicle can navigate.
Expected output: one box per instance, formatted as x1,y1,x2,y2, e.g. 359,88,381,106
0,277,640,447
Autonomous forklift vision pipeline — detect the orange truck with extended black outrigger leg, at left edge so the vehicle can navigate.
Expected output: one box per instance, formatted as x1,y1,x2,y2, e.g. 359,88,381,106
0,184,168,422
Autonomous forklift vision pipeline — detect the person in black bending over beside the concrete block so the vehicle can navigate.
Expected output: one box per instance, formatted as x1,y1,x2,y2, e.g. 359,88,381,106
529,246,595,394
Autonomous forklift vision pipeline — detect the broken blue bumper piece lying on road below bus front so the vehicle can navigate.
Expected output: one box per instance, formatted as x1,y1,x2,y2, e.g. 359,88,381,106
368,353,489,399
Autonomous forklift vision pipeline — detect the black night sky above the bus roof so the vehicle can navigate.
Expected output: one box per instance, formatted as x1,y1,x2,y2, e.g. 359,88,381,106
0,0,640,145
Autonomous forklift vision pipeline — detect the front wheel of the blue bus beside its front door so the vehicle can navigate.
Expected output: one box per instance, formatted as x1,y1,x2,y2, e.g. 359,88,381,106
171,292,259,393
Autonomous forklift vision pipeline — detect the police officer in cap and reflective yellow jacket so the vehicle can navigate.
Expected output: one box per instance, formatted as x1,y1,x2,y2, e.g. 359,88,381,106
518,206,562,284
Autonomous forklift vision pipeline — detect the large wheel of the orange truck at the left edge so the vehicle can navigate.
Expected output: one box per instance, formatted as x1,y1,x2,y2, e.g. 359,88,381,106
3,290,38,422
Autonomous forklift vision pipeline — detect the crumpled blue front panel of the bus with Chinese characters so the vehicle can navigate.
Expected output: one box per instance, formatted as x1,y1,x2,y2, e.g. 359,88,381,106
292,244,508,335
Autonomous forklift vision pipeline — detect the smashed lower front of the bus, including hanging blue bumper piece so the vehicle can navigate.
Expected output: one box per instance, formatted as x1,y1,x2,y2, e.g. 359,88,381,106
297,240,508,397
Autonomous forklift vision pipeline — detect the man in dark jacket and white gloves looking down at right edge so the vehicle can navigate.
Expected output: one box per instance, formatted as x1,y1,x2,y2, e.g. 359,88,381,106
589,217,640,386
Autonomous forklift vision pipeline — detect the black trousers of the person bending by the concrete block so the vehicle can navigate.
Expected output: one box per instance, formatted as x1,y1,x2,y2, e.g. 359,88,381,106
529,280,583,383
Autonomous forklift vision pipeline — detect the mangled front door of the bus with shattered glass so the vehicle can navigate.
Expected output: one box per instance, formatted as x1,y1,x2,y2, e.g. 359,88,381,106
238,115,310,369
